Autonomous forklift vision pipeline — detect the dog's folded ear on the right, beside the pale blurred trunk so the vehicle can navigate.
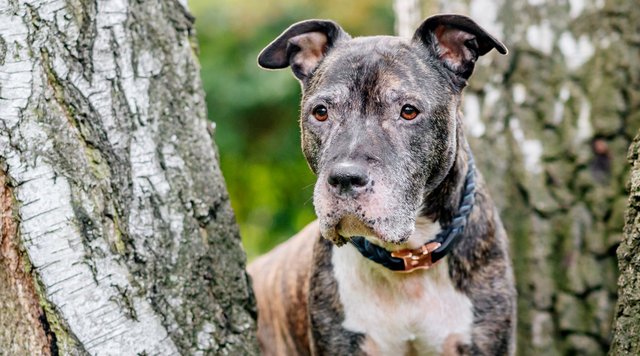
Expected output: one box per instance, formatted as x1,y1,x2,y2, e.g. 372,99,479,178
413,15,507,80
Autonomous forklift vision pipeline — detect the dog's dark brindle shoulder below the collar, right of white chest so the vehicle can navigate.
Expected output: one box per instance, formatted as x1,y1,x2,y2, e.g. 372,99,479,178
449,174,517,355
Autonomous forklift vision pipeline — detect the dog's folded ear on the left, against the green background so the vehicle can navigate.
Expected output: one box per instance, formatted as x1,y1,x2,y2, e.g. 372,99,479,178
258,20,351,82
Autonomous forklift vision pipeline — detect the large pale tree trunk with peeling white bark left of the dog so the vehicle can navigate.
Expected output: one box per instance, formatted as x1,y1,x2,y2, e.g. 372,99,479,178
0,0,257,355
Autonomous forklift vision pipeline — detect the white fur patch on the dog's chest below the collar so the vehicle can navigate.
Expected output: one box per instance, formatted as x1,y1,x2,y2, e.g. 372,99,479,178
332,220,473,356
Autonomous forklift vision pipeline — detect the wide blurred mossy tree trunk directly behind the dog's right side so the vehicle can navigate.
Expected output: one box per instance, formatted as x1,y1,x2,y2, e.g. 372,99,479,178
430,0,640,355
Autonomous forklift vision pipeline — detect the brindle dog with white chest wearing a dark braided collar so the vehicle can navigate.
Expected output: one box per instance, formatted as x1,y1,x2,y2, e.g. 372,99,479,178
248,14,516,355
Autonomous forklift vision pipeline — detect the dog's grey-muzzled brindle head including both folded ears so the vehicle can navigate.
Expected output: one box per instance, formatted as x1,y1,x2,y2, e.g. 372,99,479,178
258,15,506,244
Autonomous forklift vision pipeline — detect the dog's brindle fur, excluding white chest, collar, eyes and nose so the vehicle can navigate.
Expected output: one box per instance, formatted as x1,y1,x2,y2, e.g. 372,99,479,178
249,16,516,355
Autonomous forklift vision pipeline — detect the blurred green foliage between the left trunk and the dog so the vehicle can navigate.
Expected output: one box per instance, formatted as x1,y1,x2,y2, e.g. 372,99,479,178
189,0,393,258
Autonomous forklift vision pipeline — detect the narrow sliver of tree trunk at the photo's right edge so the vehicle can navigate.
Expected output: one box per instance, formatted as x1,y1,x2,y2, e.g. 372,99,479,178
610,132,640,355
